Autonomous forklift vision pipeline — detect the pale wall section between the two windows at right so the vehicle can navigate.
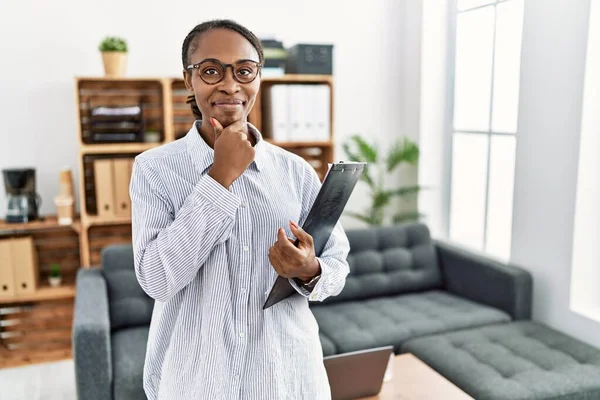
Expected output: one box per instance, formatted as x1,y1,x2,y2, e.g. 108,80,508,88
512,0,600,346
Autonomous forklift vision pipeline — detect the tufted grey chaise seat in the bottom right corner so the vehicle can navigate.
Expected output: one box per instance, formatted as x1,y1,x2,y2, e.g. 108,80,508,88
402,321,600,400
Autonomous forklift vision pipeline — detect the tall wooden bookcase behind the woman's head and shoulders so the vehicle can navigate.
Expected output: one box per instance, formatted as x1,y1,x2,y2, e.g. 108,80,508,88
75,75,334,267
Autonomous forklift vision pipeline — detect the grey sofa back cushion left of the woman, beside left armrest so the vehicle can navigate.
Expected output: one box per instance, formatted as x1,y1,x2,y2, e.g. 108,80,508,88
102,244,154,331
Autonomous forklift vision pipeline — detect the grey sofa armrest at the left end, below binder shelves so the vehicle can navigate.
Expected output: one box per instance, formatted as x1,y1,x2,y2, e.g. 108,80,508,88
73,268,112,400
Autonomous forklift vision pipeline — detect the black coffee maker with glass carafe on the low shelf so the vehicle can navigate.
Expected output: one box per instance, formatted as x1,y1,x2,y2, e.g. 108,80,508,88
2,168,41,223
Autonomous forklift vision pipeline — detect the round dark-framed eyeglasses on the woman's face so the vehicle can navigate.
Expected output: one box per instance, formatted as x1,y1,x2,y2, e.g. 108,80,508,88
186,58,262,85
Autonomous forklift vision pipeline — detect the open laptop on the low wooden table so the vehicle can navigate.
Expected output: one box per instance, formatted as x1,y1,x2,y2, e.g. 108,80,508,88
323,346,394,400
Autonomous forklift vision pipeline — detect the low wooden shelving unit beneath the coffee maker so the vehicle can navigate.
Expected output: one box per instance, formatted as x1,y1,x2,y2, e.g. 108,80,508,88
0,216,81,368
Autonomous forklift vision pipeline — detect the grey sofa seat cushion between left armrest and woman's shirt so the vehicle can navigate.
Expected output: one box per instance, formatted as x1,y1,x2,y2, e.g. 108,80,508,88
111,326,149,400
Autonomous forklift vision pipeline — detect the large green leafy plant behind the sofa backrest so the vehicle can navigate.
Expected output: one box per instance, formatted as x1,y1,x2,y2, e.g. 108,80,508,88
343,135,424,226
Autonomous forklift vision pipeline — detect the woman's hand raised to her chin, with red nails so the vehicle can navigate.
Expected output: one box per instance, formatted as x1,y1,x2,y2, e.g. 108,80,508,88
208,118,255,189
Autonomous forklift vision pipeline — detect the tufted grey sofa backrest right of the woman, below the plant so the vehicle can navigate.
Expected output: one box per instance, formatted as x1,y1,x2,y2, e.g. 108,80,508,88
315,223,442,304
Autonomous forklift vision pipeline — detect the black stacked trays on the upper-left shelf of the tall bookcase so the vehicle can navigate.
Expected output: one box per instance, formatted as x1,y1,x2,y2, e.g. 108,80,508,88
82,103,144,144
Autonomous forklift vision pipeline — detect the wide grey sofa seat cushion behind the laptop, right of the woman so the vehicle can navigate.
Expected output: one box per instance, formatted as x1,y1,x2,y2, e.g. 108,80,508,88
312,291,510,353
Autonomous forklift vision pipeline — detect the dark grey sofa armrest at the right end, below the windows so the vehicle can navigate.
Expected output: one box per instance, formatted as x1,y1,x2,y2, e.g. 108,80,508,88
435,241,533,320
